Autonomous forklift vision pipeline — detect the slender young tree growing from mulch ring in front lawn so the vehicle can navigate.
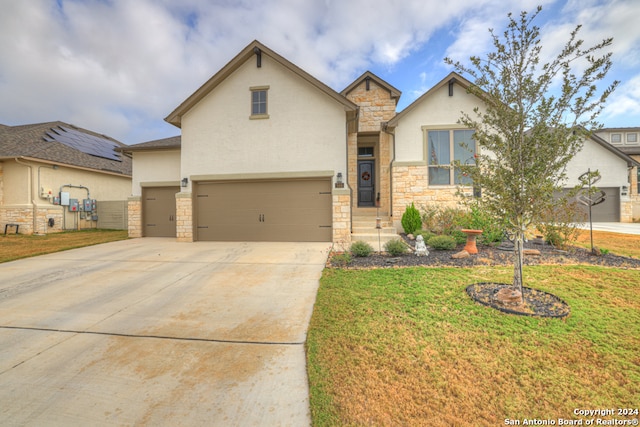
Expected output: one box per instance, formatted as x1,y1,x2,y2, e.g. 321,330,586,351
445,7,618,301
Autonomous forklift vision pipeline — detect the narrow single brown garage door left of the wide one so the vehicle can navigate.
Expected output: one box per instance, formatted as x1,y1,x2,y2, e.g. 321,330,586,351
142,187,180,237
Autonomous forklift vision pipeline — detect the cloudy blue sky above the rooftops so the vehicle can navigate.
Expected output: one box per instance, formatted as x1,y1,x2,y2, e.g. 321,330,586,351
0,0,640,144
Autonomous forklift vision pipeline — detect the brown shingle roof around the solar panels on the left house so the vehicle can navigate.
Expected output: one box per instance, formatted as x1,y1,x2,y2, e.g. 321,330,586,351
0,121,131,176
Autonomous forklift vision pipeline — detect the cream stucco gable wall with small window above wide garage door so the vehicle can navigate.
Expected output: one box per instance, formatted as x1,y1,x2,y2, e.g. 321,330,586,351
181,56,346,184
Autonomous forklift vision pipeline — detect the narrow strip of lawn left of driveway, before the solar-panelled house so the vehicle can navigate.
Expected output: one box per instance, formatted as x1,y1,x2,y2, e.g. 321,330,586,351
0,229,128,263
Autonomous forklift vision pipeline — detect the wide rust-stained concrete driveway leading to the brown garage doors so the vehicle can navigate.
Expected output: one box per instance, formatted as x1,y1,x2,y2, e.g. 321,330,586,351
0,238,330,426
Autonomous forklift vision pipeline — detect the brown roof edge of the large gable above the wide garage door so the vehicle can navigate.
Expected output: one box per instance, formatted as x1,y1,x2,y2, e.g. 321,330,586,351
165,40,358,127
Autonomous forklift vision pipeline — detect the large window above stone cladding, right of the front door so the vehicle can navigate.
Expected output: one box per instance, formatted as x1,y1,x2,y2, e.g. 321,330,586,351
427,129,476,185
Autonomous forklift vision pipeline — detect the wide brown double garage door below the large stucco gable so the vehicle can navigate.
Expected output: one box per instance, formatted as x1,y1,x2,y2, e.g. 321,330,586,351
195,179,332,242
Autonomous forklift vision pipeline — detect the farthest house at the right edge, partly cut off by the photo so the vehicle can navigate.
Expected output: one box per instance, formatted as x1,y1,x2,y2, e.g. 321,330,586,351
596,127,640,220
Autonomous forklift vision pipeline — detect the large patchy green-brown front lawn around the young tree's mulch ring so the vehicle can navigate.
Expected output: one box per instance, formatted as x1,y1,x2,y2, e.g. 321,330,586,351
307,266,640,426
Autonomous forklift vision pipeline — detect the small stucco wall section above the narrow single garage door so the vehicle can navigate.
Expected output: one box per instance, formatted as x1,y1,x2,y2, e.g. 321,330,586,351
131,150,181,196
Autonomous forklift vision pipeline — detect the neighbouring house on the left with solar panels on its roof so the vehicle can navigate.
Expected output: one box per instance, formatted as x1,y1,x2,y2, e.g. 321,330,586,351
0,122,131,234
